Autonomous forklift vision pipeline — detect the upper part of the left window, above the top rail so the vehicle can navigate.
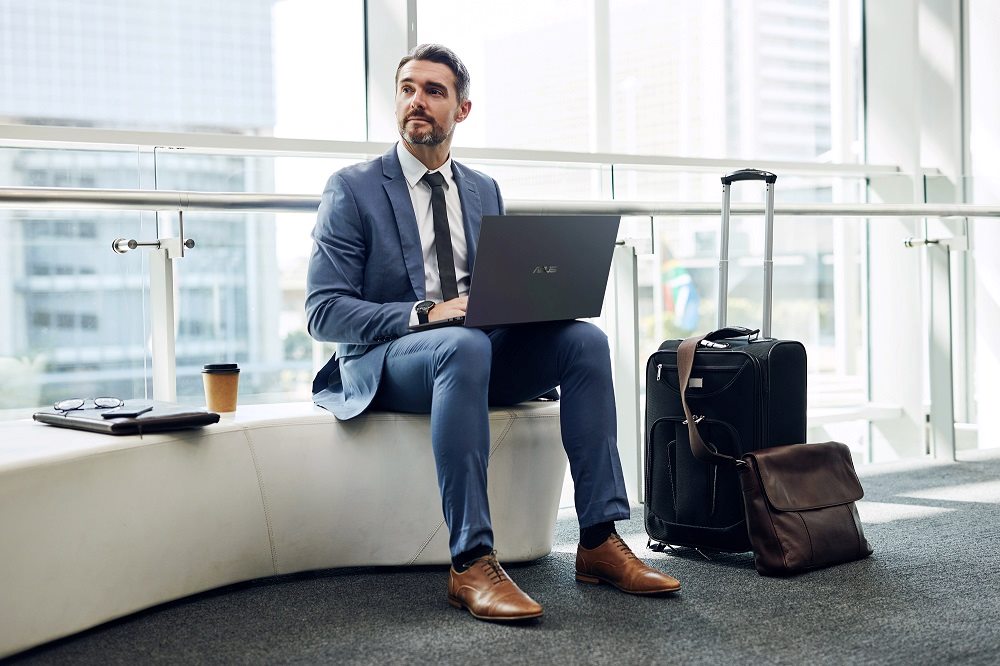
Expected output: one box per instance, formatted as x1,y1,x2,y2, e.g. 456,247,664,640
0,0,365,140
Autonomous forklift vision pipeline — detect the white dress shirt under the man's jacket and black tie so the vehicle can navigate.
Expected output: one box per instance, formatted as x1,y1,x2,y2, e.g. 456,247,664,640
396,142,471,324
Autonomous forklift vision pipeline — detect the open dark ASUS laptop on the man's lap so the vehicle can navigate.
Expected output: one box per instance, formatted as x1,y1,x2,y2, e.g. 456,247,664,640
410,215,621,331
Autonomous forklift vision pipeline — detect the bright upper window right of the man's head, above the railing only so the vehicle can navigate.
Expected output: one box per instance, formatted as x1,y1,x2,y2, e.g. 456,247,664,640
417,0,861,162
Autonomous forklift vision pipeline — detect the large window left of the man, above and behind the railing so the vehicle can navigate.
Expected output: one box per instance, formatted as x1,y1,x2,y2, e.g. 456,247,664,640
0,0,366,415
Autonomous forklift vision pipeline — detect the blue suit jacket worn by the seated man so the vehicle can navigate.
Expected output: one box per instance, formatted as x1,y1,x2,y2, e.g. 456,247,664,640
306,146,503,419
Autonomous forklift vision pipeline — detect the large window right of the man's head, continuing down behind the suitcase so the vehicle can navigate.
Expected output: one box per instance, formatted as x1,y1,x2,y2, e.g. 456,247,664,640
417,0,867,428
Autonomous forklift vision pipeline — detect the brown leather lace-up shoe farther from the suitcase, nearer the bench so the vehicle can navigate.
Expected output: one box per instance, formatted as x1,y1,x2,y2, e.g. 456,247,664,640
448,553,542,622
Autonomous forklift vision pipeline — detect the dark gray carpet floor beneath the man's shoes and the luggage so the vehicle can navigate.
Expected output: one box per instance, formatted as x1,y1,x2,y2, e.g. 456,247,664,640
9,451,1000,664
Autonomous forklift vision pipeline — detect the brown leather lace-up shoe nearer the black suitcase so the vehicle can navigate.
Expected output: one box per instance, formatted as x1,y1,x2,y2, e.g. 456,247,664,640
576,533,681,594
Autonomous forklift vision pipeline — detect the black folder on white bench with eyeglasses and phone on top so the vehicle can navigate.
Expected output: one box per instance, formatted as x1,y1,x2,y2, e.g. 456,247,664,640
32,400,219,435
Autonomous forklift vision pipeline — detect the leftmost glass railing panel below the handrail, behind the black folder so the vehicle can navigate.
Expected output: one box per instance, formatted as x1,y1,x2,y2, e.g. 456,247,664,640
0,209,155,418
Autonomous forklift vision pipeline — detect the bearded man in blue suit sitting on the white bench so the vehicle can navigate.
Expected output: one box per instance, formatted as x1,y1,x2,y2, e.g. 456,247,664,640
306,44,680,621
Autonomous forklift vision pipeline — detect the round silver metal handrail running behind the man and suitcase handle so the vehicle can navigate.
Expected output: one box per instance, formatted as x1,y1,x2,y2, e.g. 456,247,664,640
0,187,1000,218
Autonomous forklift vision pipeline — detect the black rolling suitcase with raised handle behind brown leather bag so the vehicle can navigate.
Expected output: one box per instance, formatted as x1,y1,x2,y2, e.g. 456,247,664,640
644,169,806,552
